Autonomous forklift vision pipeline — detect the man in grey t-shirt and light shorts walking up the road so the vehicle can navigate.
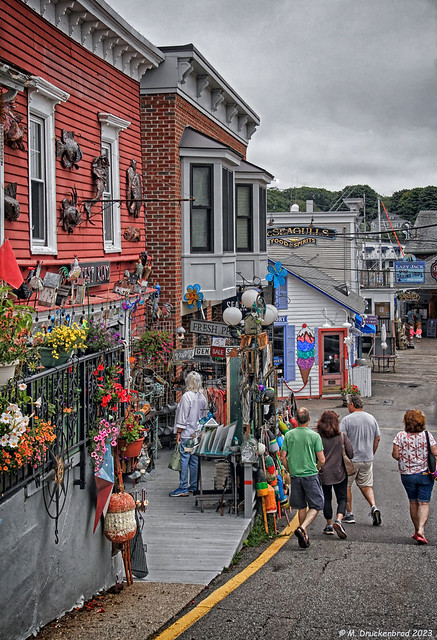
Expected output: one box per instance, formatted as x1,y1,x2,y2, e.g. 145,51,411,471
340,393,381,527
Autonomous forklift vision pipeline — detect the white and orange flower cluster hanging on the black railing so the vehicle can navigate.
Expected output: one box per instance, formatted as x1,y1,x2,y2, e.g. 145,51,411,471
0,383,56,473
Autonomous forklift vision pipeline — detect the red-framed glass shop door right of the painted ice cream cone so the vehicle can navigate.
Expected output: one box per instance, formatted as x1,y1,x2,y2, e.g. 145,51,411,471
319,329,346,396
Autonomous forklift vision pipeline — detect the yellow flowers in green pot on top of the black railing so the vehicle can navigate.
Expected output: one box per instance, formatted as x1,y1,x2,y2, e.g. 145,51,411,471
33,322,86,367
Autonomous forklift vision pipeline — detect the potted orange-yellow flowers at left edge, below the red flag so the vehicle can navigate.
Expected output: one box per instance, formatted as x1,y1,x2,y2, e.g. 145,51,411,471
0,285,33,385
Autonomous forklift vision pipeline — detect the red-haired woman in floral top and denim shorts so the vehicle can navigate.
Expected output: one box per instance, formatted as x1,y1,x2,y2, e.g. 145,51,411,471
392,409,437,544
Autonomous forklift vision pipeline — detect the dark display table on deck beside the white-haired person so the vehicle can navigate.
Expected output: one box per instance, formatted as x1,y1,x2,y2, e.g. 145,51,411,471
194,451,238,516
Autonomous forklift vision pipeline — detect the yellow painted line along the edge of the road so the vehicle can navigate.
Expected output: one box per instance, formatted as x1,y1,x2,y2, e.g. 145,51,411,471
155,514,299,640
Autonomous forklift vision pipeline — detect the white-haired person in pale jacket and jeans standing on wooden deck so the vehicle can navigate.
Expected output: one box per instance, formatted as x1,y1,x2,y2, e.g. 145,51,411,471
169,371,208,498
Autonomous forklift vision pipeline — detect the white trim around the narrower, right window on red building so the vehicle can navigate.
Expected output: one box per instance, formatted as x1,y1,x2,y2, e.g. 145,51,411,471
98,113,131,253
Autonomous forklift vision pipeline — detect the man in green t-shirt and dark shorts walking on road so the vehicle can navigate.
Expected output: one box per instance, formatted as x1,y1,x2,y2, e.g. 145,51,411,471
280,407,325,549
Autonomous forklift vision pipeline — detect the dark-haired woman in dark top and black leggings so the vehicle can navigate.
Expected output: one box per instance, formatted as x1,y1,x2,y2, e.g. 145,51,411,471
317,411,354,538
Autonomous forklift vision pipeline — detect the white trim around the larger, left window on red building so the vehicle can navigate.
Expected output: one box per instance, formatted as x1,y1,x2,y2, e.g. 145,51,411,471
28,76,70,255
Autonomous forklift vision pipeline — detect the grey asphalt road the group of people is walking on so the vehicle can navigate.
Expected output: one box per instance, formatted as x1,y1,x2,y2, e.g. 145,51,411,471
172,340,437,640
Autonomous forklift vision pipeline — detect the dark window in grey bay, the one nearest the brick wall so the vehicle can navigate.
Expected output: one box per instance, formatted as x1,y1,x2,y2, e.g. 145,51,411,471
190,164,214,253
